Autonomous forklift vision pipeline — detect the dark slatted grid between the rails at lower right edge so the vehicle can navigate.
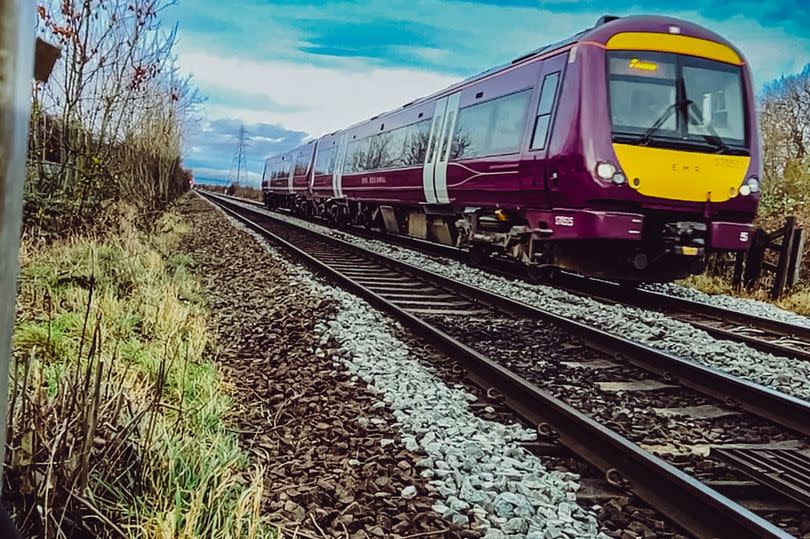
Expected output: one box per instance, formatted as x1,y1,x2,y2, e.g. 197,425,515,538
711,447,810,507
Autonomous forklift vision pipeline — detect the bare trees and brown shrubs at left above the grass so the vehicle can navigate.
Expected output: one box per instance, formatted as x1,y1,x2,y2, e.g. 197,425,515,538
24,0,199,235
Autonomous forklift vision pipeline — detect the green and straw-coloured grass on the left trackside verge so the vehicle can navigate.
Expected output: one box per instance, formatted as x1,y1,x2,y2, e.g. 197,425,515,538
5,209,276,539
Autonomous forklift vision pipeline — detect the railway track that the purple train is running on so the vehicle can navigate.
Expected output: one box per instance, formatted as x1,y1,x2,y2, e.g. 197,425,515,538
210,192,810,361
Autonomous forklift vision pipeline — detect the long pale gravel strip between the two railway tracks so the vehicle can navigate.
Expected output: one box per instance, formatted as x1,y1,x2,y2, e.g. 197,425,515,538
245,205,810,400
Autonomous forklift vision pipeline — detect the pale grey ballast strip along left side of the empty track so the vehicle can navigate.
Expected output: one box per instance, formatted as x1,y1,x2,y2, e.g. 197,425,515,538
218,205,607,539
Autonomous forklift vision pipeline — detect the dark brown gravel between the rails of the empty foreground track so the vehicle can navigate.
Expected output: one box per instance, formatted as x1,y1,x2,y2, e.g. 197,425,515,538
433,316,796,464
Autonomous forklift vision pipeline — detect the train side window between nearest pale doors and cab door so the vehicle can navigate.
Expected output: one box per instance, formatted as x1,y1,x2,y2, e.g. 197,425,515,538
450,89,531,160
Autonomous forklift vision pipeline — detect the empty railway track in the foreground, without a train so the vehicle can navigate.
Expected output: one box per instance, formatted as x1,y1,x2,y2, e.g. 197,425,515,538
206,195,810,537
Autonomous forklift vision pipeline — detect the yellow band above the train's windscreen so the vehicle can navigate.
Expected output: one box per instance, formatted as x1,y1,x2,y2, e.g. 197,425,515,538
607,32,743,65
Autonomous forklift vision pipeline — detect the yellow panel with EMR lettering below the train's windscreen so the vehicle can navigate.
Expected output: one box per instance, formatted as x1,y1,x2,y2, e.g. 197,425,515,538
613,144,751,202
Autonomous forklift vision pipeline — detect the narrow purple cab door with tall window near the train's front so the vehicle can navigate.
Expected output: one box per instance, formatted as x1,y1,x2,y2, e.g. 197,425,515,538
529,54,568,205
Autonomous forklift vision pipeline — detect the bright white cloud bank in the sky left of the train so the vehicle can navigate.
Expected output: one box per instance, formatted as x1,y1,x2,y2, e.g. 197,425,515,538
179,46,459,136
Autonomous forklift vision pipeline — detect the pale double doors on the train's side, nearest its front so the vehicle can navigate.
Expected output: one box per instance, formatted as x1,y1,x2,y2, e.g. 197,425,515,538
422,92,461,204
